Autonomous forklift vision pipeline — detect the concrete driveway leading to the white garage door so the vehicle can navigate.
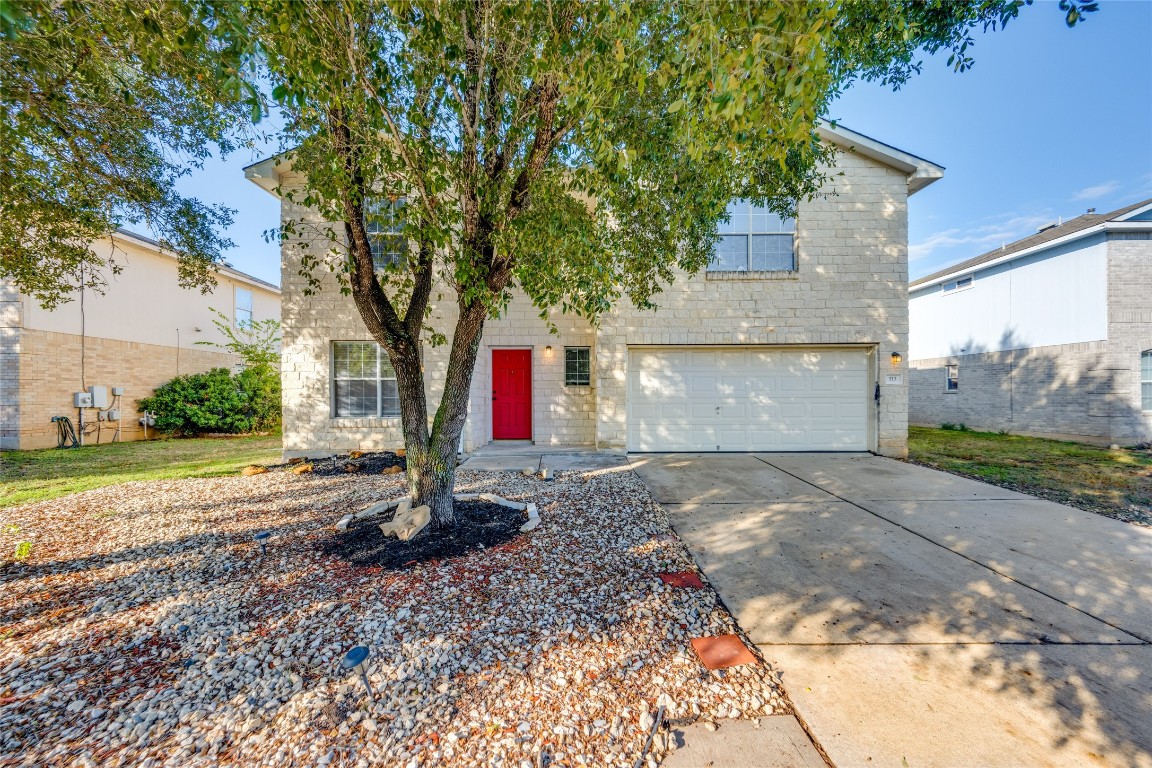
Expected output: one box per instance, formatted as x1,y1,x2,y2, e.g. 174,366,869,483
630,454,1152,768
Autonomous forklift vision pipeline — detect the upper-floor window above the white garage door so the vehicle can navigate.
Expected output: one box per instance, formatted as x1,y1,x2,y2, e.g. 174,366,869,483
708,200,796,272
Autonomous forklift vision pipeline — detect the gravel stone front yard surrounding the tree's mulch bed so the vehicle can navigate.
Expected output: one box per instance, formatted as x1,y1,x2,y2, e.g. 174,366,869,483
0,462,788,768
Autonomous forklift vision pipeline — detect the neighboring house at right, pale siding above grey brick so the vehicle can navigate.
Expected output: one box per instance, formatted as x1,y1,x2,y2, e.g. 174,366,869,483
909,199,1152,444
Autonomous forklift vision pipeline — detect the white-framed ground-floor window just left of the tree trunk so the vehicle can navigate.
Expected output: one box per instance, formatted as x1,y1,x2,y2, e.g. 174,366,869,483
332,341,400,417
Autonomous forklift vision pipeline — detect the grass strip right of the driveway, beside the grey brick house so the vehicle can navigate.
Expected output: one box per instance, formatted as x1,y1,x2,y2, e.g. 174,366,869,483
908,427,1152,517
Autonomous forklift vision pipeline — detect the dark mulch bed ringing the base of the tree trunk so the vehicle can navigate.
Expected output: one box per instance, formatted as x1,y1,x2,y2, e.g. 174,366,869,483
318,501,528,570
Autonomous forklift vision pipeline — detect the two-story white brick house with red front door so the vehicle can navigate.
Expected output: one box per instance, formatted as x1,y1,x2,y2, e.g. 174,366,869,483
245,126,943,456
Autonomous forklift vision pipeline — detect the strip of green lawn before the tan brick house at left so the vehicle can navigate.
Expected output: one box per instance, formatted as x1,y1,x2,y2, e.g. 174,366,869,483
0,434,281,508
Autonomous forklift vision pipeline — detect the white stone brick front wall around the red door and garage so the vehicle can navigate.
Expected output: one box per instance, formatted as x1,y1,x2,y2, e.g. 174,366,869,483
282,152,909,456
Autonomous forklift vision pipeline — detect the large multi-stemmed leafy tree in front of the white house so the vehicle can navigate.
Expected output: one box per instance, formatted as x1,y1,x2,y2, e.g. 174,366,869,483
259,0,1091,525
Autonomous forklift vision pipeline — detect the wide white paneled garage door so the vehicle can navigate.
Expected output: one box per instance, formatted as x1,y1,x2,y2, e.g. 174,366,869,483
628,348,870,451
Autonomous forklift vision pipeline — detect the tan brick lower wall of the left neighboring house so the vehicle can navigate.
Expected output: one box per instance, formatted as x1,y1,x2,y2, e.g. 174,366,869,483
12,329,237,449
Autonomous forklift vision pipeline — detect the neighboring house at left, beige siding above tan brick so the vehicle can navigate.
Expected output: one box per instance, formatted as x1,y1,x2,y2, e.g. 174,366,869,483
0,231,280,449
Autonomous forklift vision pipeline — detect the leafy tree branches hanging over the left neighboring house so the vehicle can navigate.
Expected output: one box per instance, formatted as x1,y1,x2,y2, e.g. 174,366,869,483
0,0,259,309
